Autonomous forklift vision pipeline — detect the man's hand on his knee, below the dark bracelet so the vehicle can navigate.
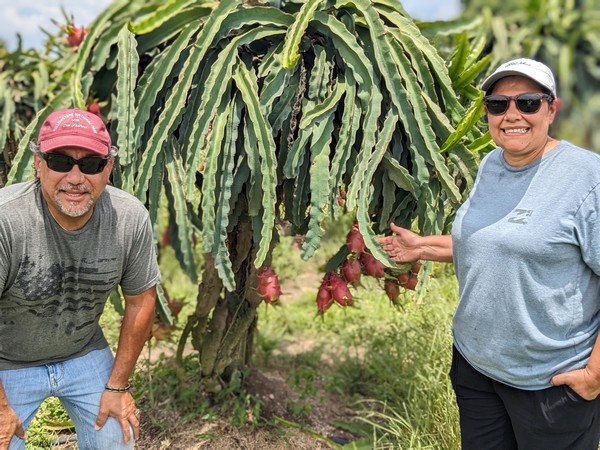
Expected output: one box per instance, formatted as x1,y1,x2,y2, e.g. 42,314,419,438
96,391,140,442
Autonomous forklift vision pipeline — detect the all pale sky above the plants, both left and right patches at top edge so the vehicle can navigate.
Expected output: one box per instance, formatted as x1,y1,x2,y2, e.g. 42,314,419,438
0,0,460,50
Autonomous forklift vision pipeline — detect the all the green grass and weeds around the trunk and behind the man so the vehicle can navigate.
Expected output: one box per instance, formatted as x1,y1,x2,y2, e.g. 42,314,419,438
27,216,460,450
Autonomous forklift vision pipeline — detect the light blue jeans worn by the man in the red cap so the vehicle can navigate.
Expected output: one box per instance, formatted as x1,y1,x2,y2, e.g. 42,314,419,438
0,347,133,450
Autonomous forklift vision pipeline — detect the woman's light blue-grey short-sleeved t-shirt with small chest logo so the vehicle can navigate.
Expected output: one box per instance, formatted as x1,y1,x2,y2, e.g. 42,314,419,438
452,141,600,390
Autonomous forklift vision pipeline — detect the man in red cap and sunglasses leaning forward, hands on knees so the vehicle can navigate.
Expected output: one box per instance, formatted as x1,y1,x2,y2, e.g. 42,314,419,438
0,109,160,450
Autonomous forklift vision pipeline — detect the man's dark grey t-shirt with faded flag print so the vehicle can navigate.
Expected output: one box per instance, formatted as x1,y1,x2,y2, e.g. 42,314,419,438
0,180,159,370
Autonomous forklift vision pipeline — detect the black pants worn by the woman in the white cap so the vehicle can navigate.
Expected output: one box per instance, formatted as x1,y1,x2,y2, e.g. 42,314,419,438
450,348,600,450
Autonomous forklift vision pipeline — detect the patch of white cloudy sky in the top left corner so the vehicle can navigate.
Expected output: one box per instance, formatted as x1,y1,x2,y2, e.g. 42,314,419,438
0,0,111,50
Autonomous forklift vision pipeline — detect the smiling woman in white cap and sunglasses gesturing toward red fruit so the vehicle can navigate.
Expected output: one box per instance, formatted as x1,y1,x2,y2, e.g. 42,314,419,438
379,59,600,450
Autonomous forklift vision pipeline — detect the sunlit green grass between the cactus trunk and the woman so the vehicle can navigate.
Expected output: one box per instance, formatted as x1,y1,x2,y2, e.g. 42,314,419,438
256,256,460,450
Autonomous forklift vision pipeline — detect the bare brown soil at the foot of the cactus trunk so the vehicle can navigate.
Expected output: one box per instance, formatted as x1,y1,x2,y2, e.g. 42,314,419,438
136,371,356,450
